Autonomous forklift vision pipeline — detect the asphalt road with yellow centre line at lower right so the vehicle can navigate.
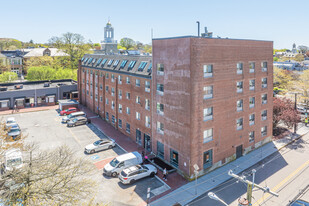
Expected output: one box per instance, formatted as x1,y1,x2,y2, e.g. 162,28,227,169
189,134,309,206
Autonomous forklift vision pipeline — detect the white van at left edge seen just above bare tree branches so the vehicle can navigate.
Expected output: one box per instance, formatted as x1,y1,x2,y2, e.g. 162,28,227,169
4,149,23,171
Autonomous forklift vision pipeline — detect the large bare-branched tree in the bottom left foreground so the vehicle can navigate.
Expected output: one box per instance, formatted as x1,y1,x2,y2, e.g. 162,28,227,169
0,146,96,205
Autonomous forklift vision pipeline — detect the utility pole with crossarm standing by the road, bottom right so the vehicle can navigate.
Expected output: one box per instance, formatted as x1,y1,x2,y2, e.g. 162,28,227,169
228,170,279,205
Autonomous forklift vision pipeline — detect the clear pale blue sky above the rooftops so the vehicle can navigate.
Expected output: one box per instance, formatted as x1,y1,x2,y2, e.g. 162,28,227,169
0,0,309,49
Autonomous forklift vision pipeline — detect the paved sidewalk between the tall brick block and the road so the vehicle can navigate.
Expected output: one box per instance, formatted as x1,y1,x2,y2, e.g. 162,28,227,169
150,124,309,206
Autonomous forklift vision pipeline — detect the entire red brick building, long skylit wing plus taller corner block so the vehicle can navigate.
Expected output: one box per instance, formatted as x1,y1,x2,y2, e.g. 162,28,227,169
78,37,273,177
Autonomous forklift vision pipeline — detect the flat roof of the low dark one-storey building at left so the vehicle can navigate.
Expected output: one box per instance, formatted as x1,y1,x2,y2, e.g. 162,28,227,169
0,79,77,92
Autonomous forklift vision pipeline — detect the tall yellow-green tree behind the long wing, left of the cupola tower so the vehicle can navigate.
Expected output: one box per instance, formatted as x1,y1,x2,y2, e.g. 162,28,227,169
49,32,91,69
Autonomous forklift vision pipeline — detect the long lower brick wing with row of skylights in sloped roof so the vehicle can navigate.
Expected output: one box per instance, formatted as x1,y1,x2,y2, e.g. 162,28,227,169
78,54,152,151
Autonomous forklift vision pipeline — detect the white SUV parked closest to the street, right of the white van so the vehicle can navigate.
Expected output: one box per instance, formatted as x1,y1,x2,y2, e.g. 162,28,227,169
119,164,157,184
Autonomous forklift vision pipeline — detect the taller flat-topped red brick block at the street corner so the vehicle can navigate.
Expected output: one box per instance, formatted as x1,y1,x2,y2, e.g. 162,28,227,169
152,37,273,177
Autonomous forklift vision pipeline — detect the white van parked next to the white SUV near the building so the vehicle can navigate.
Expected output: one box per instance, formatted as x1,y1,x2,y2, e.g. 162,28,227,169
103,152,143,177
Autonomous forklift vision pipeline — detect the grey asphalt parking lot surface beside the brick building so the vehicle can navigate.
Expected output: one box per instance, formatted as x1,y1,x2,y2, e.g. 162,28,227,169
4,110,169,205
